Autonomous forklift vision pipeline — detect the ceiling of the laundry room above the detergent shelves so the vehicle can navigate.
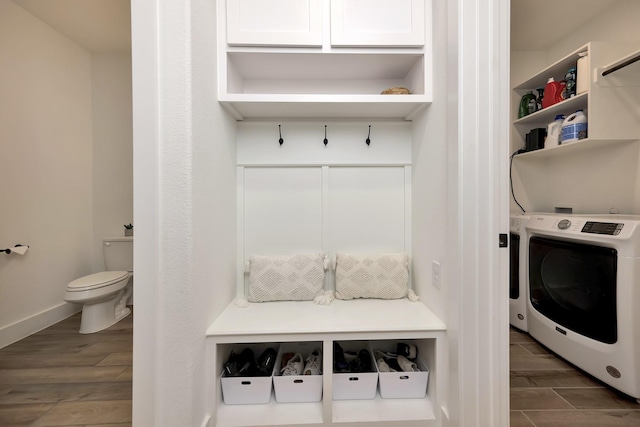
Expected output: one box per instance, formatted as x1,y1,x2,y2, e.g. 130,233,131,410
511,0,619,50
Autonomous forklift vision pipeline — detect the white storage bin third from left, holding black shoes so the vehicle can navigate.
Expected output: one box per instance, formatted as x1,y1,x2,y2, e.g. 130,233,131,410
331,341,378,400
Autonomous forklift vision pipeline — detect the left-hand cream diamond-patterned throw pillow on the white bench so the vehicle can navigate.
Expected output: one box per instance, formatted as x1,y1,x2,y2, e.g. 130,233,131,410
247,254,324,302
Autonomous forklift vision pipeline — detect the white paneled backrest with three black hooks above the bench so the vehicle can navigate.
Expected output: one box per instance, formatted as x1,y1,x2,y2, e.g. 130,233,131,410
237,122,411,295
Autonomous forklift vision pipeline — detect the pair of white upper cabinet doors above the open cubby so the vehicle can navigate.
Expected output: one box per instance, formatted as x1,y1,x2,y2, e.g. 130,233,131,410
227,0,425,47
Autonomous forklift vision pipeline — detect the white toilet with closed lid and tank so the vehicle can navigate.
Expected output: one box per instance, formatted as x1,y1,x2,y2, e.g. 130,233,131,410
64,237,133,334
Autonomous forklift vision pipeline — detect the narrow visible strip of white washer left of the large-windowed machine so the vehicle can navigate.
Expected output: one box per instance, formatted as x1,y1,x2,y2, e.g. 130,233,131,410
509,214,530,332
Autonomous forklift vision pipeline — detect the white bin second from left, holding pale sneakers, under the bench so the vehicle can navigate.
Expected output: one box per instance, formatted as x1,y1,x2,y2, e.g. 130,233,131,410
273,342,322,403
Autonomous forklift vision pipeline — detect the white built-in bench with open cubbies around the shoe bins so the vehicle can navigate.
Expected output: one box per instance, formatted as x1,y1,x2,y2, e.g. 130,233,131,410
207,299,445,427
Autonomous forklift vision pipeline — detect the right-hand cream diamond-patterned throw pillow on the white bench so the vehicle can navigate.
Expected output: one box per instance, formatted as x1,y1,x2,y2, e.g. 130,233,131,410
336,253,409,299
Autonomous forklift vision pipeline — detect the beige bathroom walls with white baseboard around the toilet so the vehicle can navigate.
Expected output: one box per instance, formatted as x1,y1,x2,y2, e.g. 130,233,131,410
0,0,133,348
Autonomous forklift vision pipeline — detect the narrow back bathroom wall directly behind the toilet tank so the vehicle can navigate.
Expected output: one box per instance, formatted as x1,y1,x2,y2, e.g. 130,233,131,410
91,53,133,271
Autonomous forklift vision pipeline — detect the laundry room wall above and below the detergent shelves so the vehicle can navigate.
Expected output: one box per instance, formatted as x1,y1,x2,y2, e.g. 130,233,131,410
511,0,640,214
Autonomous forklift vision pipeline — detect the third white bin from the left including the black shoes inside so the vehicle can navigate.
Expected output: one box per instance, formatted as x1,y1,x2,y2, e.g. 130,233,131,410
333,341,378,400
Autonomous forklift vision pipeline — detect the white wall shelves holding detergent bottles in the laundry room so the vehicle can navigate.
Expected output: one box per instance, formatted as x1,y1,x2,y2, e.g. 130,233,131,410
513,42,640,159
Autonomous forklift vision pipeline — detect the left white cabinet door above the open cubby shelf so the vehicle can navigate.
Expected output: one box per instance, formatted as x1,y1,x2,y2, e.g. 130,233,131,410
227,0,322,46
